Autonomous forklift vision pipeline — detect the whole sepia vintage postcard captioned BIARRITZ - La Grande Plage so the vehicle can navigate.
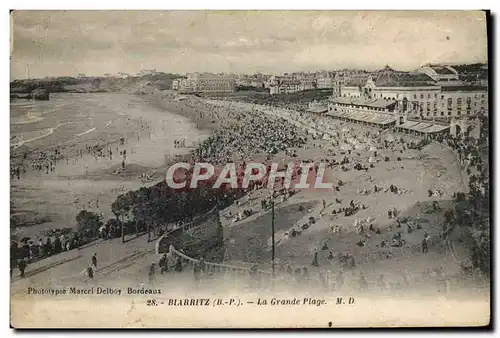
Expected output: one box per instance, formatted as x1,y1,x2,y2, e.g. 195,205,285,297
10,10,491,329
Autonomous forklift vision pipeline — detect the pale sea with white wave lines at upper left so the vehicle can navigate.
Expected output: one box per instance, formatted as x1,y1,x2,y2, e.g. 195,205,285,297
10,93,208,162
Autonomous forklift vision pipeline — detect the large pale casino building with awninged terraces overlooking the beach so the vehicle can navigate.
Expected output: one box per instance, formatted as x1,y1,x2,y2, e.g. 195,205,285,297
327,65,488,136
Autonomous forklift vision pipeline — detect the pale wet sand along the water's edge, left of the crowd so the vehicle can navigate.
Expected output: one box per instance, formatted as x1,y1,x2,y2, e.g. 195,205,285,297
10,93,213,237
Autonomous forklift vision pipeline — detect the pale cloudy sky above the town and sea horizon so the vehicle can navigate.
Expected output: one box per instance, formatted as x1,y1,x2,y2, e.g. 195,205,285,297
11,11,487,79
